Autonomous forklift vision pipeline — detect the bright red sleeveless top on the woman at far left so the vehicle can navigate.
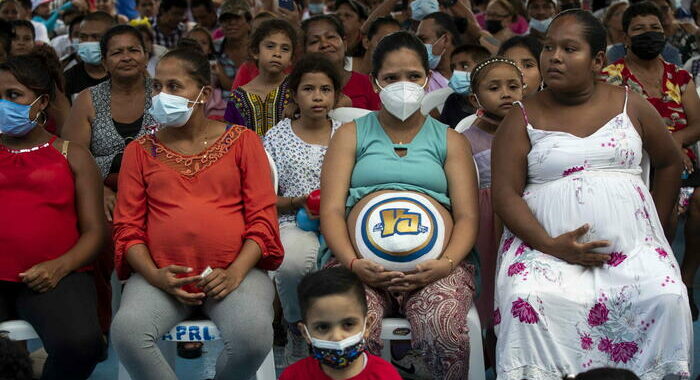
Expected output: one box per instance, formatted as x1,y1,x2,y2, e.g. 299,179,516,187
0,136,80,282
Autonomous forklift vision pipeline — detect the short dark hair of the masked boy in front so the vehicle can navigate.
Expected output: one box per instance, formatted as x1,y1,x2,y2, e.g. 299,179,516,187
297,267,367,321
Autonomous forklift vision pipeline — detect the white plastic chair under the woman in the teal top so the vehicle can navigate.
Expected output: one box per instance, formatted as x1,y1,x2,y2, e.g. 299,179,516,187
380,305,486,380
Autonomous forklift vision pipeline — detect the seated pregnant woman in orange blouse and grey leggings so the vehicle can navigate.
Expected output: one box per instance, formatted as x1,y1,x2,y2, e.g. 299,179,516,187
111,48,283,380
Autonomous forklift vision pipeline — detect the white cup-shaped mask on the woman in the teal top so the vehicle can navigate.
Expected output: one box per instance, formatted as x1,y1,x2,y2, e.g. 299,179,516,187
375,78,428,121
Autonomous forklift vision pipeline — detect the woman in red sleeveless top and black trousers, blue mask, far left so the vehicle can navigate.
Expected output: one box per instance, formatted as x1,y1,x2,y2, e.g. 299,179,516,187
0,52,106,379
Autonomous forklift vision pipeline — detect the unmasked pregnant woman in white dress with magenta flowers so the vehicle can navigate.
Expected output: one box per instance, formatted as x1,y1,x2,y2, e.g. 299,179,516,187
492,10,693,380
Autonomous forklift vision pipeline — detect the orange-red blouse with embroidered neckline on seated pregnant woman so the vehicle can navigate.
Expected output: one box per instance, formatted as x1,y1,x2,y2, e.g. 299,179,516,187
114,126,284,279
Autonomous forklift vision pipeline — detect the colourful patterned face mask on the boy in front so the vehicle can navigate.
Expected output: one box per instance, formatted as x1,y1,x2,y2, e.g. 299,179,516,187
304,325,366,369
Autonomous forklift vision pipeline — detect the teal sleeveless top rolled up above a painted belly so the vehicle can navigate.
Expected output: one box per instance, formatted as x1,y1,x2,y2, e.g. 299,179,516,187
345,112,450,208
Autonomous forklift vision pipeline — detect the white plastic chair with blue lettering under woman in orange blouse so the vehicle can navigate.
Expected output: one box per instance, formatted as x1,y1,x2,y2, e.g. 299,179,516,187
119,320,277,380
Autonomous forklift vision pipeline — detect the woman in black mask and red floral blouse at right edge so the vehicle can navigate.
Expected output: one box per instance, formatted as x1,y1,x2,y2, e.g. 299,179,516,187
602,2,700,319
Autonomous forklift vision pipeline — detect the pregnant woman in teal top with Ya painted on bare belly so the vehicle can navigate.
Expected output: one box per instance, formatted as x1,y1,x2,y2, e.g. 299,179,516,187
321,32,478,379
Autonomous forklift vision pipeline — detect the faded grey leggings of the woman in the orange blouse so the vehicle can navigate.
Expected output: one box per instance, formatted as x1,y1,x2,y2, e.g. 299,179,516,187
111,268,275,380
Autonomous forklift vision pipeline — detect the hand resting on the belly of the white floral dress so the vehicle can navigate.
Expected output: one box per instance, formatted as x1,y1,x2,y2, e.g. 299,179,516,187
546,224,610,266
